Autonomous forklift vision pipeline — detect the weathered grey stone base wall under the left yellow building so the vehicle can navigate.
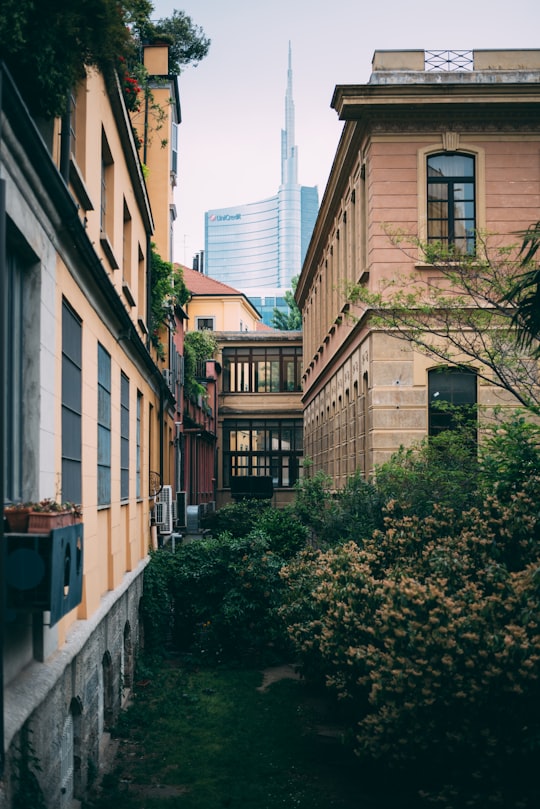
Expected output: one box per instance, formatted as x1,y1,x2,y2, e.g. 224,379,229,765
0,563,145,809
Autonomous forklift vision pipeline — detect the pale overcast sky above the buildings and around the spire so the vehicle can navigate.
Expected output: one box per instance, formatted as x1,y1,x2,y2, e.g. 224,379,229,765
152,0,540,266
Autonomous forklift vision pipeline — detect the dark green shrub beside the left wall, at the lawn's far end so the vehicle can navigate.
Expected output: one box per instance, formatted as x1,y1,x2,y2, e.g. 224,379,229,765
143,531,285,660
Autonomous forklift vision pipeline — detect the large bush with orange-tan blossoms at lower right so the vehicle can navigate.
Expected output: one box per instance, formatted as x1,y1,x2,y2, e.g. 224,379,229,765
281,477,540,807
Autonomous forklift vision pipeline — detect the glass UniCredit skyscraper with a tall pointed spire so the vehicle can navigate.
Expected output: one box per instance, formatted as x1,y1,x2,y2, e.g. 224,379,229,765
205,43,319,324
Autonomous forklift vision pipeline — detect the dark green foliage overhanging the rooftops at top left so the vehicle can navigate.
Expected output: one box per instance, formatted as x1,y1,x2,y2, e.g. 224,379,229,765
0,0,210,119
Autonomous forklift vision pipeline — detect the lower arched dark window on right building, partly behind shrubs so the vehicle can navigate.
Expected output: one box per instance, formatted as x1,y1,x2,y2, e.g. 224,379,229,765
428,366,477,435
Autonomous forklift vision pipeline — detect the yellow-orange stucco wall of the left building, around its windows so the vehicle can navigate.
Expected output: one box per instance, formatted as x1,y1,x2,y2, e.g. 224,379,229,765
51,66,169,644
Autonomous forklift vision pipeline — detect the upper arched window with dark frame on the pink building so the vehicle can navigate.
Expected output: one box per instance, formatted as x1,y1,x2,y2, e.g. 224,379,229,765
427,152,476,255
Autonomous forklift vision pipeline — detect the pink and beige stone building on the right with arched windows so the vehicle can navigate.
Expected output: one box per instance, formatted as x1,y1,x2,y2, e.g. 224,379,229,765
296,50,540,487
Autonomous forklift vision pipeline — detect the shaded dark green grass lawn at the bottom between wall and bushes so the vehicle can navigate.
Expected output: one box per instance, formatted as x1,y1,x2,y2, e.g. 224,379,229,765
88,664,396,809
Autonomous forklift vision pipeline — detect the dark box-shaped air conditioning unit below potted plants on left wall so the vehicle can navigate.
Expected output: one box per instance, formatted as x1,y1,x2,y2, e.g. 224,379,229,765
4,523,84,626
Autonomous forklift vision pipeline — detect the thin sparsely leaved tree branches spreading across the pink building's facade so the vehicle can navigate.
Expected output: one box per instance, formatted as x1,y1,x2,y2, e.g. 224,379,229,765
347,233,540,412
